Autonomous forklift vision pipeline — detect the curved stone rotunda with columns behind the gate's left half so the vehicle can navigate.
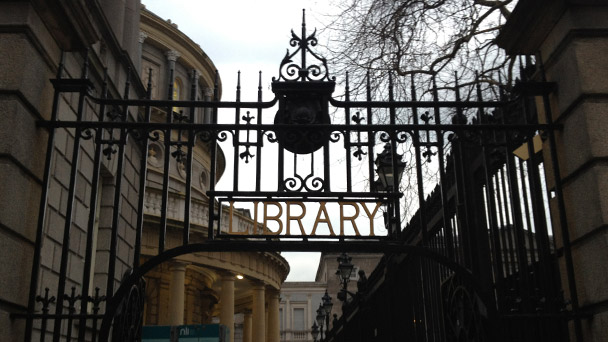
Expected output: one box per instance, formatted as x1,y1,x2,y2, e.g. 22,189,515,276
140,9,289,341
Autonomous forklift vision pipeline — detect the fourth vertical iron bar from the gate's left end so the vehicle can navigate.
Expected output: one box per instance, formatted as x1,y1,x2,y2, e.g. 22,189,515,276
106,68,131,298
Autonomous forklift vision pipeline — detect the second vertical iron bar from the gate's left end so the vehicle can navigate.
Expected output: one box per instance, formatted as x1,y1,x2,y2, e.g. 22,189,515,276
53,50,89,342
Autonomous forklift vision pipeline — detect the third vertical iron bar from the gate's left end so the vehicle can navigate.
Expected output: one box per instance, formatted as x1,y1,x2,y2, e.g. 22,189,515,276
78,69,108,341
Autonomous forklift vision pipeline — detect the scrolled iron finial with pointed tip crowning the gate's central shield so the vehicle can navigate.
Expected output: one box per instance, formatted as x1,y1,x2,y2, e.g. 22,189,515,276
273,10,335,81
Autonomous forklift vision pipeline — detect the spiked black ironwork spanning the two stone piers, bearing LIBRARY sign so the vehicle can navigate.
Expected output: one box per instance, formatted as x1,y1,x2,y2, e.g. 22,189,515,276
15,10,577,342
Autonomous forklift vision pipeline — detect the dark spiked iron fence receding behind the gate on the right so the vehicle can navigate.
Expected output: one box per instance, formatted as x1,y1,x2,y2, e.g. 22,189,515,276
326,72,577,341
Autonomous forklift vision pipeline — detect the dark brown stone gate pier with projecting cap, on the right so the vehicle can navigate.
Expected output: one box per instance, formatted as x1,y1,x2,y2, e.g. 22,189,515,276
498,0,608,342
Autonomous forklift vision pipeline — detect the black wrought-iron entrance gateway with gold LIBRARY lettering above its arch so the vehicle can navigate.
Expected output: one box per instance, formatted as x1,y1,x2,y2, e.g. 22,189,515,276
26,9,571,342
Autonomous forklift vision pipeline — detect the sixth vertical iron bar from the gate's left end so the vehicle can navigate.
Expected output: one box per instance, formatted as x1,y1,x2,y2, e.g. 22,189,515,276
158,68,174,250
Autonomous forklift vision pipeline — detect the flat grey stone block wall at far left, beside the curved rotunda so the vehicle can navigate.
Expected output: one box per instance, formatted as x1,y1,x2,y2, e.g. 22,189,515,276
0,0,143,341
